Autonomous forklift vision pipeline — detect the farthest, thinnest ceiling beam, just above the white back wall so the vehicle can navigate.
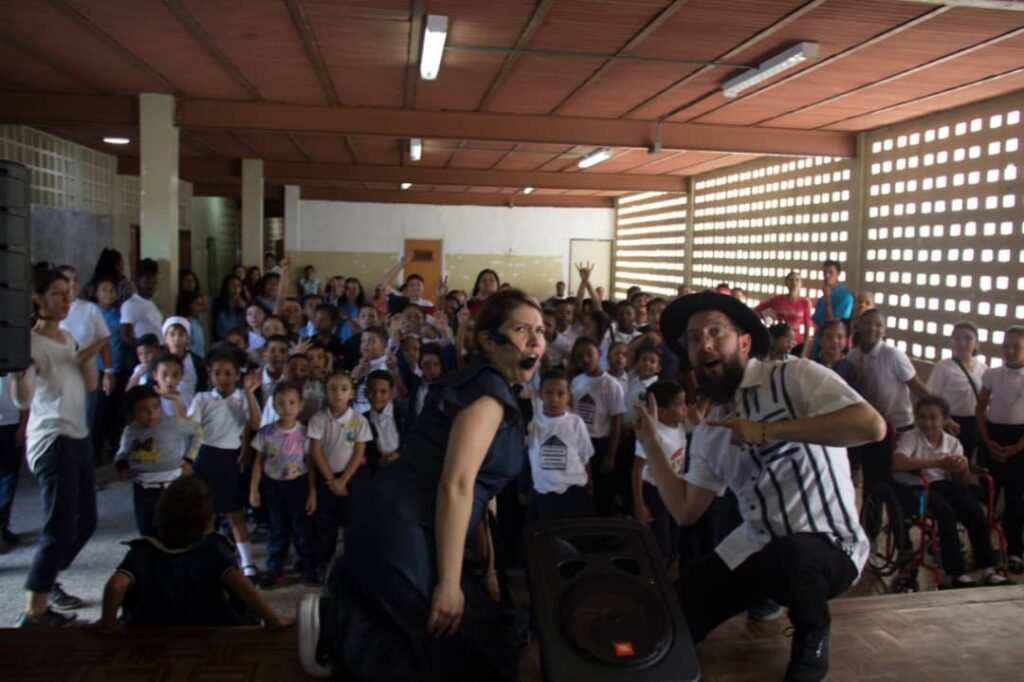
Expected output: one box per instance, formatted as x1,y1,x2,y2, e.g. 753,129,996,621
193,182,614,209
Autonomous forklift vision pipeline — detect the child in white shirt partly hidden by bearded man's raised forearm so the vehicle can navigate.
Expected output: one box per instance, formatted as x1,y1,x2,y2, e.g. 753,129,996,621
633,381,686,564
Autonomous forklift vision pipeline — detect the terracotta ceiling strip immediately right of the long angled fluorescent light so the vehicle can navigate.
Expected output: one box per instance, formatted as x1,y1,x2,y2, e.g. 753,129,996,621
697,9,1024,125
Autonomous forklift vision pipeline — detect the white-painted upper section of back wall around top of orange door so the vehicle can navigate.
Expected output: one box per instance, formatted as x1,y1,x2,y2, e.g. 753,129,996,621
296,201,615,280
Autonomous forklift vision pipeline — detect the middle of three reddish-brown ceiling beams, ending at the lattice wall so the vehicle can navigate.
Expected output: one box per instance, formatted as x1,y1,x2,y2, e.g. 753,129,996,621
118,157,686,191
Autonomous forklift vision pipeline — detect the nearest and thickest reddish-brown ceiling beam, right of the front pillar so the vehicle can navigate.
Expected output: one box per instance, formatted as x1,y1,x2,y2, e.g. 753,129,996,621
178,93,855,157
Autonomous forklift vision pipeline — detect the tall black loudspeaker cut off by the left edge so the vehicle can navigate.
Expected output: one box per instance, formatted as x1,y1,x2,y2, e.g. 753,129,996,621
0,161,32,374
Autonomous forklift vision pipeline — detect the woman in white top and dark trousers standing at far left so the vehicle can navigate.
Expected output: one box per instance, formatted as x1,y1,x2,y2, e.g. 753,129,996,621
14,270,108,627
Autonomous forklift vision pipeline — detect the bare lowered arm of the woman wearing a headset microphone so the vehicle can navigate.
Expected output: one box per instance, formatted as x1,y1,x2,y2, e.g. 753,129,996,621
427,396,504,636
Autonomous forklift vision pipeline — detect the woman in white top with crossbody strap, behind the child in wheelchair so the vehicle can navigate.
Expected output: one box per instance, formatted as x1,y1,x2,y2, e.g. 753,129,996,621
928,322,988,459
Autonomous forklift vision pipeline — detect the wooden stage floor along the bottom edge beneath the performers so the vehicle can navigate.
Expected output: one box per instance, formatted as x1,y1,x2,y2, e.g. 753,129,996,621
0,586,1024,682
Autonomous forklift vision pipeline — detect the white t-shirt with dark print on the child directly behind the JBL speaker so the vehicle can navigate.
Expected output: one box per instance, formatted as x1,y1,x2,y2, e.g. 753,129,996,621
526,412,594,495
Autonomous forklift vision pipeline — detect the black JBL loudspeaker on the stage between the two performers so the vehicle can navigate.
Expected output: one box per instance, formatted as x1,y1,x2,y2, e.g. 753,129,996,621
524,518,700,682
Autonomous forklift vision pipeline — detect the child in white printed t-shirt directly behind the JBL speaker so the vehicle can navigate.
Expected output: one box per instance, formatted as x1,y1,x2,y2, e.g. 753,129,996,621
526,370,594,521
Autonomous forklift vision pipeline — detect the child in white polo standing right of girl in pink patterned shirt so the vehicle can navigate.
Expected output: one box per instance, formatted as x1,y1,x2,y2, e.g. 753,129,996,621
308,373,373,576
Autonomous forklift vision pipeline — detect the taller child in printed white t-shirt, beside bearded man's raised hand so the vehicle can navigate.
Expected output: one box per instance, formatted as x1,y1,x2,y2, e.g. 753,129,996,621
570,336,633,516
